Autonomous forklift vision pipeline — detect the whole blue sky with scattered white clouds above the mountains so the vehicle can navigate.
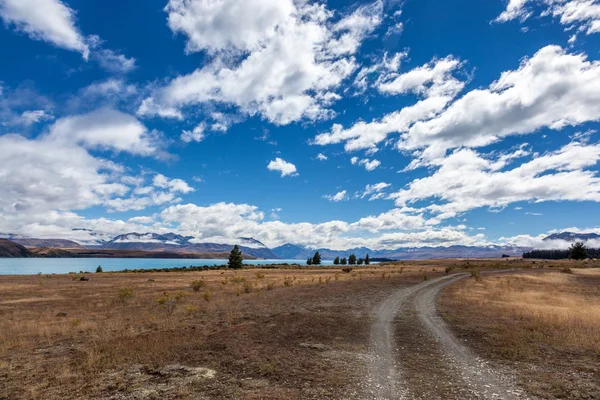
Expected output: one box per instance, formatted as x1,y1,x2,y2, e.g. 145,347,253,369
0,0,600,249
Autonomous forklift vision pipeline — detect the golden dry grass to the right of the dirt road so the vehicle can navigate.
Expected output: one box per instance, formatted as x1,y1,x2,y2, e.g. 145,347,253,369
440,265,600,399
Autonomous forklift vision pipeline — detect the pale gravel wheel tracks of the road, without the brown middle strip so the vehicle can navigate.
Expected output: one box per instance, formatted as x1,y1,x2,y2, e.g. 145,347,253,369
364,274,528,400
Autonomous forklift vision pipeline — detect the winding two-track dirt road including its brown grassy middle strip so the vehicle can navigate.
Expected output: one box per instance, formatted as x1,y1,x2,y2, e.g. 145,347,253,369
364,274,528,400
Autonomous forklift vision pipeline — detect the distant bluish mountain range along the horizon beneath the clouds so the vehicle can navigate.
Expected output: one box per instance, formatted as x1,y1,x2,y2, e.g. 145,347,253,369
2,231,600,260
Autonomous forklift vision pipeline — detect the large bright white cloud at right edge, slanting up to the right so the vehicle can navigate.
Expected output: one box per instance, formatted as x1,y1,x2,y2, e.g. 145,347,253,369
399,46,600,160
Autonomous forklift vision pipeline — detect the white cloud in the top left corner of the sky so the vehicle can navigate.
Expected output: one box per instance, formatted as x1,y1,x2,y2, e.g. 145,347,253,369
0,0,90,59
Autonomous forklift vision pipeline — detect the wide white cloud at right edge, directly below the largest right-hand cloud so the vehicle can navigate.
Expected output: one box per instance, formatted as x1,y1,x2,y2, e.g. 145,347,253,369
390,142,600,223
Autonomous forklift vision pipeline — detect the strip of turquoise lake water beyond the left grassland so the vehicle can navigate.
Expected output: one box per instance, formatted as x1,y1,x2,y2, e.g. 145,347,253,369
0,258,342,275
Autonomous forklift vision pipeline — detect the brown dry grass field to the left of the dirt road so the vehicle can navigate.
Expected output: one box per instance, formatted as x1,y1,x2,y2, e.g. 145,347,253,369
0,265,438,399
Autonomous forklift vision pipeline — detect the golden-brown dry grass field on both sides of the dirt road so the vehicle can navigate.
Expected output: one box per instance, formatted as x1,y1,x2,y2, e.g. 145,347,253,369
0,260,600,399
